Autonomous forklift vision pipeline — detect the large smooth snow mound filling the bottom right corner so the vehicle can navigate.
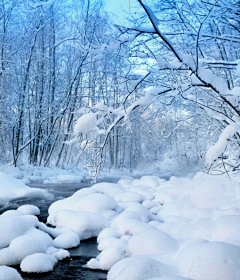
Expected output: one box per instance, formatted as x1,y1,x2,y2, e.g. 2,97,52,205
176,242,240,280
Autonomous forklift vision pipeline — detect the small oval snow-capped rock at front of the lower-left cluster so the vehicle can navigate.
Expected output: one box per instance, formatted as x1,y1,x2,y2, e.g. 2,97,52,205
20,253,57,273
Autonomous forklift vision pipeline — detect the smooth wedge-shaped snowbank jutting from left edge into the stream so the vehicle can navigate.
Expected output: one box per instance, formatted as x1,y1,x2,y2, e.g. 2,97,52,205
0,171,53,201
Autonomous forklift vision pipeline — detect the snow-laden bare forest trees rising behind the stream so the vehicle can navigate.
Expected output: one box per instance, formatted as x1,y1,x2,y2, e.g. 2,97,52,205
0,0,240,177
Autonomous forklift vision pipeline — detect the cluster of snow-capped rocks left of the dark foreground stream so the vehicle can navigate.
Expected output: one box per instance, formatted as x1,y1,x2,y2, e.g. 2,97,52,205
0,205,71,274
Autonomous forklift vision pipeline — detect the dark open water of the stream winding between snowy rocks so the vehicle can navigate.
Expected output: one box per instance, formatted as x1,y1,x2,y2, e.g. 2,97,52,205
0,180,110,280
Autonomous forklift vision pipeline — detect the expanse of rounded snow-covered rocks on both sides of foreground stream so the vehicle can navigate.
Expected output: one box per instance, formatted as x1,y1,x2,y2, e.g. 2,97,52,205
0,170,240,280
